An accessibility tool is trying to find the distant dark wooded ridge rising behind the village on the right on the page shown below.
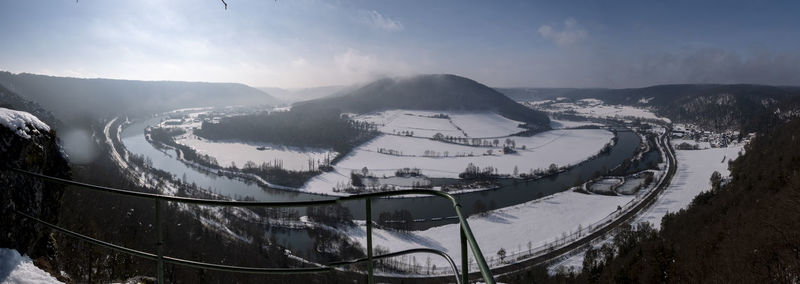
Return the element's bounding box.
[498,84,800,132]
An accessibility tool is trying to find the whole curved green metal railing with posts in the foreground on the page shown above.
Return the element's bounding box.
[10,169,495,283]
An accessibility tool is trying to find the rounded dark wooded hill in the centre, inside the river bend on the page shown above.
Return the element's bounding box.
[294,74,550,129]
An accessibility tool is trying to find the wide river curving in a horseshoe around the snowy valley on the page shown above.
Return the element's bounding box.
[121,118,658,228]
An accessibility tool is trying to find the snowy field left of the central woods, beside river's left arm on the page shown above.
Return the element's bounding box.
[175,135,337,171]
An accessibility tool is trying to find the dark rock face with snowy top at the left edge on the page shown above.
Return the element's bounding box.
[0,108,70,264]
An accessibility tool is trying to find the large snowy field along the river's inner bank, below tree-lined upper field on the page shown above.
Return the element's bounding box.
[303,129,613,194]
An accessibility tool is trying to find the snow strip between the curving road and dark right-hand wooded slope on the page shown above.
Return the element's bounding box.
[637,144,743,228]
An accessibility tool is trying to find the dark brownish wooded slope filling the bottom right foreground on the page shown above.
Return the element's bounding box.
[520,119,800,283]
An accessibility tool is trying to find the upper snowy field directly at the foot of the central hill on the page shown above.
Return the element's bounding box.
[353,110,525,138]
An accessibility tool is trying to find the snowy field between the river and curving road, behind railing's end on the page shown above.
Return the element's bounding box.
[348,191,634,267]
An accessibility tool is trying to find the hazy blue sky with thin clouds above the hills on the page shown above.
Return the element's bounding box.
[0,0,800,88]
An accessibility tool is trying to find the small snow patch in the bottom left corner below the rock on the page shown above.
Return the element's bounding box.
[0,248,63,284]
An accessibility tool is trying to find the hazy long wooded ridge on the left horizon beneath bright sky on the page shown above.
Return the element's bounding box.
[0,72,277,122]
